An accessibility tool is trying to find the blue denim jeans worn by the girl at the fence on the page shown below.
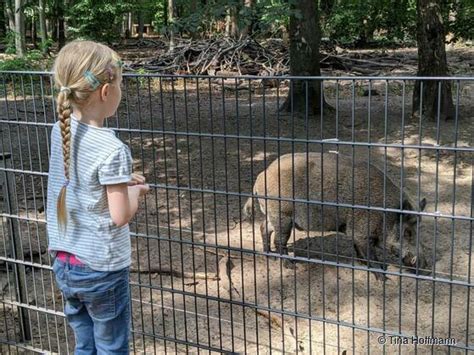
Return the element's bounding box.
[53,259,130,355]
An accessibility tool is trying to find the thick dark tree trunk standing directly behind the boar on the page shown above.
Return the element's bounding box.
[281,0,326,114]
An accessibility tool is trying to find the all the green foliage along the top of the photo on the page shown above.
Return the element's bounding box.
[0,0,468,51]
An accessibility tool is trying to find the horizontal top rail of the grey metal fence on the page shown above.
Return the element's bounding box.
[0,70,474,81]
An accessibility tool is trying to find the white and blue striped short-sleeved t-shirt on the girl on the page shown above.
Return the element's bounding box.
[46,115,132,271]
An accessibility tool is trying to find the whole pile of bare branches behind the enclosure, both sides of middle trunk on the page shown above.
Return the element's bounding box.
[124,37,417,76]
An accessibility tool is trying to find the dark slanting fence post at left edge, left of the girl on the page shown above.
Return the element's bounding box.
[0,153,31,341]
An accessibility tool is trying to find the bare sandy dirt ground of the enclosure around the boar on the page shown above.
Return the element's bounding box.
[0,48,474,354]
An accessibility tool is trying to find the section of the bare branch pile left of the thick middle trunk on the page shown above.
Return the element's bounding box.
[127,37,289,76]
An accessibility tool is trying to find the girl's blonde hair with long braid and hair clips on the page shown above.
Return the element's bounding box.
[53,41,122,231]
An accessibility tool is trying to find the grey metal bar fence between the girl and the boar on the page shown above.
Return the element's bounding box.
[0,72,474,354]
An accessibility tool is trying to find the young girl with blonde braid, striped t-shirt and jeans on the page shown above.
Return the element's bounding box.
[47,41,149,354]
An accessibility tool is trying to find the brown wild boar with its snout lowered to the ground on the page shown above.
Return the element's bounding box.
[244,153,427,279]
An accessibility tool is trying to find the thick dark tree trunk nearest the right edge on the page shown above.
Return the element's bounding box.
[413,0,454,120]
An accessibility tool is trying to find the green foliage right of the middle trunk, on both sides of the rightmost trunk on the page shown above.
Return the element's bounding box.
[321,0,474,45]
